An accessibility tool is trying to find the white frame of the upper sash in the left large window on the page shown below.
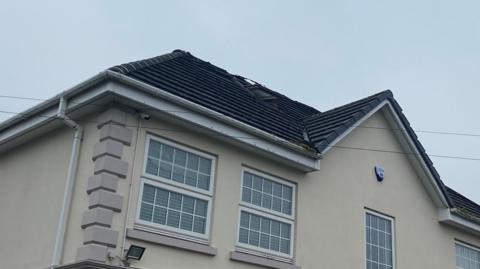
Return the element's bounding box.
[142,134,216,196]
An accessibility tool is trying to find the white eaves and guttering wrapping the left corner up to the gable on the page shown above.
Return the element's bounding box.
[0,71,320,172]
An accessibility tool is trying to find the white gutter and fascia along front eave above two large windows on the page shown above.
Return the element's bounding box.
[106,79,320,172]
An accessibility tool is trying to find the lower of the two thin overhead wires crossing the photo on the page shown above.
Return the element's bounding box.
[0,110,480,161]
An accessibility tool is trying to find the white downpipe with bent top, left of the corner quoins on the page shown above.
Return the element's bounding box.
[50,97,83,268]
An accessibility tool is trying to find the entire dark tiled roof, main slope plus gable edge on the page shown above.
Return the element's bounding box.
[109,50,480,218]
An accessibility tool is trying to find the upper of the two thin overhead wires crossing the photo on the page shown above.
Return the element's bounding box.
[0,95,480,137]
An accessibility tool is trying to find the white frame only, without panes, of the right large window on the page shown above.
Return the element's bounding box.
[235,167,297,261]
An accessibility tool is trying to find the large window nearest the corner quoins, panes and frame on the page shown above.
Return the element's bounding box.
[137,135,215,239]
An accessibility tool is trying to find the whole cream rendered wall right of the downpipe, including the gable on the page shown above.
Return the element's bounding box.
[57,107,480,268]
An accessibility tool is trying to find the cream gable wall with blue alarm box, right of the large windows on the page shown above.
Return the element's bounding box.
[297,112,480,269]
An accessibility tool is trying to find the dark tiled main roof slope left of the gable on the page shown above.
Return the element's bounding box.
[110,50,319,143]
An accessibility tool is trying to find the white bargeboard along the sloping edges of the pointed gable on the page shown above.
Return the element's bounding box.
[321,100,449,208]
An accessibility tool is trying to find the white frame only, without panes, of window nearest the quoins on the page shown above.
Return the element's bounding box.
[135,134,216,243]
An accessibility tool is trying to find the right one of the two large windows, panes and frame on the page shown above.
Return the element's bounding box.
[237,169,295,258]
